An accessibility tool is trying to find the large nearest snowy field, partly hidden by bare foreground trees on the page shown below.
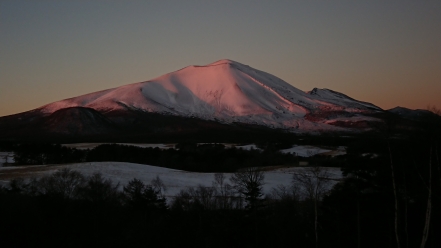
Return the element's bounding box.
[0,162,342,197]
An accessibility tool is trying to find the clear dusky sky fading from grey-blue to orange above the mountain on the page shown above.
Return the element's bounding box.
[0,0,441,116]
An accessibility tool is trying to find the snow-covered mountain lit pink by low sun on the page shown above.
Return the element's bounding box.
[31,60,382,132]
